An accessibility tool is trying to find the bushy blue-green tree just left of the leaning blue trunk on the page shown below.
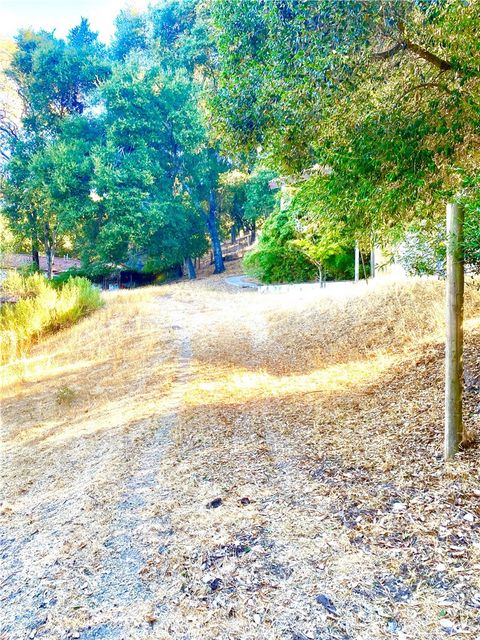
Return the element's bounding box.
[74,58,206,270]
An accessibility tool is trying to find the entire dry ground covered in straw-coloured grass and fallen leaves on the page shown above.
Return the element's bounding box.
[0,266,480,640]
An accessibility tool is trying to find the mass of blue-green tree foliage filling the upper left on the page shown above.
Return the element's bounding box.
[2,0,263,274]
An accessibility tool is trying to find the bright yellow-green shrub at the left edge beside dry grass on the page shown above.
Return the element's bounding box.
[0,272,102,362]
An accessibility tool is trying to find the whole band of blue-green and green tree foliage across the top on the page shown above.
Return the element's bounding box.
[6,0,480,279]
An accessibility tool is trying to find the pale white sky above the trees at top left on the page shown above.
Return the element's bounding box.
[0,0,151,42]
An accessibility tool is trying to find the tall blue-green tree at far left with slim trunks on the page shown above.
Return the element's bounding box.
[3,19,109,276]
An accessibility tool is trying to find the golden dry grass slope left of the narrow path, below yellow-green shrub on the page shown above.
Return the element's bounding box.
[1,289,182,500]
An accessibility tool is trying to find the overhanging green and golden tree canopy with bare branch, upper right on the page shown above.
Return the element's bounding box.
[210,0,480,255]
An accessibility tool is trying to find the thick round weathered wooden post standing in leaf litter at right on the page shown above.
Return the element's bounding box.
[444,204,464,460]
